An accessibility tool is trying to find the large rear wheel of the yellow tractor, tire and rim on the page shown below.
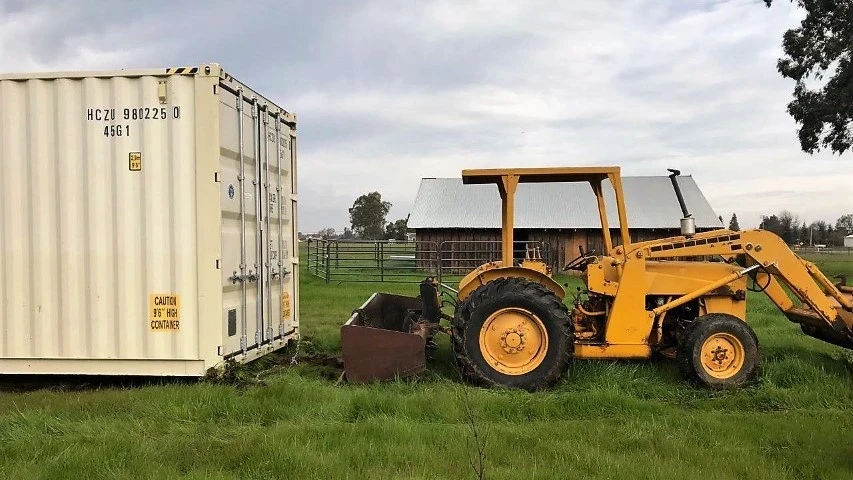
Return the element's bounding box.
[452,278,574,391]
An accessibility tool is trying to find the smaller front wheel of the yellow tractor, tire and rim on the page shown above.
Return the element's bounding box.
[676,313,761,390]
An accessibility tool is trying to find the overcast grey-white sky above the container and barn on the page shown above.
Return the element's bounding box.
[0,0,853,232]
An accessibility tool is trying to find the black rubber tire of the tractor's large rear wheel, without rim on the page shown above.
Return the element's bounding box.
[452,278,574,391]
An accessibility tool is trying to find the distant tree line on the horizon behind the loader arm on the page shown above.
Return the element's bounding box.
[729,210,853,247]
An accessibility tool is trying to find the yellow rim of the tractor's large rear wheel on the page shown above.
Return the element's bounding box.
[480,307,548,375]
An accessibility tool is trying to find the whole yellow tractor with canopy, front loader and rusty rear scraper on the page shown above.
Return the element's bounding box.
[341,167,853,390]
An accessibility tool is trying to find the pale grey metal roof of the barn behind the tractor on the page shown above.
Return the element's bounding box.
[408,176,722,229]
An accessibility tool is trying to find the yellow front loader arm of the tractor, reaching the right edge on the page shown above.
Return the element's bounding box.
[617,230,853,349]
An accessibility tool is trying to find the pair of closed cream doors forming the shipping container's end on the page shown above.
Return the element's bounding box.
[220,88,298,358]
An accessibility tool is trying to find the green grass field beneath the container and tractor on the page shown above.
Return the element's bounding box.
[0,256,853,480]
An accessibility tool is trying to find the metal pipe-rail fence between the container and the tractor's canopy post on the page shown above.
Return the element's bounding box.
[306,239,551,283]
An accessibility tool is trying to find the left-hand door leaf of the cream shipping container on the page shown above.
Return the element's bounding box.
[220,86,263,358]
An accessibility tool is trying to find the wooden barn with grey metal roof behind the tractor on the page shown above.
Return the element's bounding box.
[408,176,723,271]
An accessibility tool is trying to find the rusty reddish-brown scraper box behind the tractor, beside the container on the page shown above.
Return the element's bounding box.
[341,293,427,383]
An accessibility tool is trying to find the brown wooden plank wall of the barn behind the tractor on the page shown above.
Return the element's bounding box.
[415,228,712,273]
